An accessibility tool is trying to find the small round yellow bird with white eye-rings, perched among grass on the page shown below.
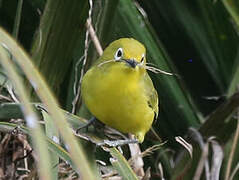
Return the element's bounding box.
[82,38,158,143]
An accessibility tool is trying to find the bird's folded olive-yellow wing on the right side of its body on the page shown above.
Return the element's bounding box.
[144,73,159,119]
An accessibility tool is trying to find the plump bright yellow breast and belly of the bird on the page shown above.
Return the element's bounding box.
[82,63,154,142]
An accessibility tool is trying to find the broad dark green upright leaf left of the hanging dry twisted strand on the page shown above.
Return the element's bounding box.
[31,0,88,97]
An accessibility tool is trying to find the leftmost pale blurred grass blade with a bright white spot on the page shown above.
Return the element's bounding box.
[0,46,52,180]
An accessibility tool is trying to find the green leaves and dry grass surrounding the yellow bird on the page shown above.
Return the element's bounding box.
[0,0,239,180]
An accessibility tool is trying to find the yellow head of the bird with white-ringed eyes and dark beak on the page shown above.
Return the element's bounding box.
[98,38,146,69]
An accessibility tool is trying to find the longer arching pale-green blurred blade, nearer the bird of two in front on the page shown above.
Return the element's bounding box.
[0,29,94,179]
